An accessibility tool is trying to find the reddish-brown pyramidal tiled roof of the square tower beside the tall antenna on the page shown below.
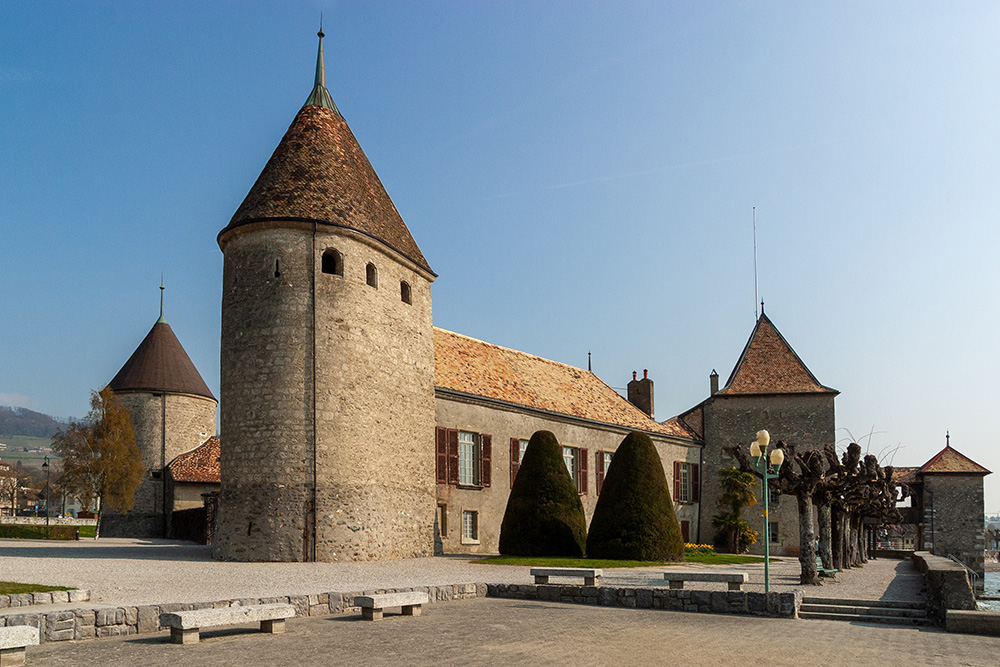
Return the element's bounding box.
[718,312,839,395]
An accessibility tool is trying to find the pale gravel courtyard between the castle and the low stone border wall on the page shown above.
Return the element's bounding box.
[0,538,923,606]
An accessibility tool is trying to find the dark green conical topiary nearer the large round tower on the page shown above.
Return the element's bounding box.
[500,431,587,558]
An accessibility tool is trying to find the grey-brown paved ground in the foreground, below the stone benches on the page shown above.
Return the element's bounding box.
[28,598,997,667]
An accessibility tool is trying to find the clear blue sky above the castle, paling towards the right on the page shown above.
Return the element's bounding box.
[0,0,1000,511]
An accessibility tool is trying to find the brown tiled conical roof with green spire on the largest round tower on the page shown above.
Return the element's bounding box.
[219,33,433,274]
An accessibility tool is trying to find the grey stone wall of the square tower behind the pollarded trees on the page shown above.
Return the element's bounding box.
[701,394,836,555]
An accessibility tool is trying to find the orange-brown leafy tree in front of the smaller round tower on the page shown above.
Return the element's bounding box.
[52,387,145,535]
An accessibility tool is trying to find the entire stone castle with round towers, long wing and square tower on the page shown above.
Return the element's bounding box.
[99,33,982,576]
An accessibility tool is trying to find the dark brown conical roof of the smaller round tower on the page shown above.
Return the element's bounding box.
[108,317,215,401]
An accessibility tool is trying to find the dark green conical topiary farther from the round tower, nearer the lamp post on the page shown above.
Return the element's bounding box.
[587,431,684,560]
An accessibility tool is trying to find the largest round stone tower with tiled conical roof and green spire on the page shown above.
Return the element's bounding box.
[214,32,435,561]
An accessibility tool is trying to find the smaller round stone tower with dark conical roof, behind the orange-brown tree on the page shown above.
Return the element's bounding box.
[101,286,218,537]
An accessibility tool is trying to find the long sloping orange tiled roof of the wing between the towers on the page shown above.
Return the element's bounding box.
[434,327,692,440]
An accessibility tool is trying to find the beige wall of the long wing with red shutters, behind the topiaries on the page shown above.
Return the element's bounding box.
[427,393,701,553]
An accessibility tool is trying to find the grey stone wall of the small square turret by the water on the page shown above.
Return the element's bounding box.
[920,473,986,593]
